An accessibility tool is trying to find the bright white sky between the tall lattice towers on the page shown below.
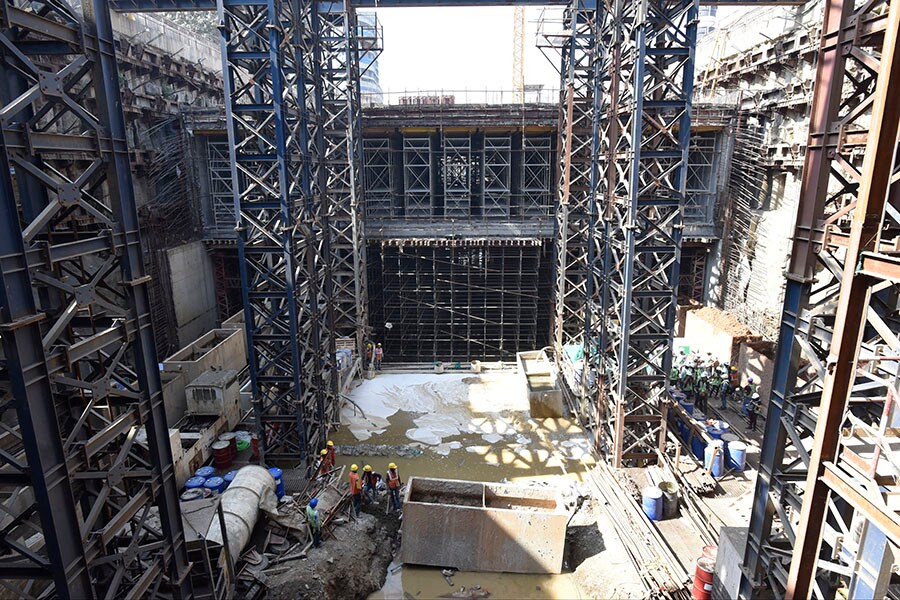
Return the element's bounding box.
[366,6,562,101]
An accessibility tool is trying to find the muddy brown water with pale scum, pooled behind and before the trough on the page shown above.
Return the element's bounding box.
[332,373,594,599]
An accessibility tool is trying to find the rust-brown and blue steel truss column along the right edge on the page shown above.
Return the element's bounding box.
[741,0,900,598]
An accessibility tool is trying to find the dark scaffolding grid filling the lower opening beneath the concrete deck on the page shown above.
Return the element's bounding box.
[369,239,551,364]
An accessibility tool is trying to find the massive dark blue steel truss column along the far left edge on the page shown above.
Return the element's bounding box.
[0,0,190,598]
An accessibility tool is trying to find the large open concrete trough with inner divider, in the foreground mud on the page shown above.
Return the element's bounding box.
[400,477,569,573]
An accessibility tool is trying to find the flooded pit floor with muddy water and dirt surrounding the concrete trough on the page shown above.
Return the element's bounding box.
[269,372,641,600]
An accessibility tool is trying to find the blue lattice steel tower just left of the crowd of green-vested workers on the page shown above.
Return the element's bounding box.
[606,0,697,466]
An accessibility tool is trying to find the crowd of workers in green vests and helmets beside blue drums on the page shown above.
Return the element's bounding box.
[669,350,760,431]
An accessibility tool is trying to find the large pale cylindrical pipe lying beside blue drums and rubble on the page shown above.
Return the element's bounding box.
[206,465,275,562]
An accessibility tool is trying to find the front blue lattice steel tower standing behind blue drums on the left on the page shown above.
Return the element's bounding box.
[218,0,318,462]
